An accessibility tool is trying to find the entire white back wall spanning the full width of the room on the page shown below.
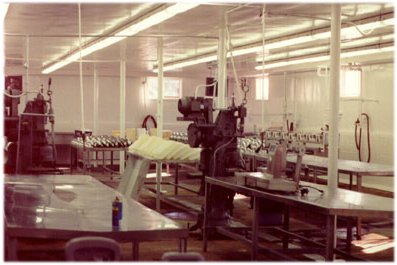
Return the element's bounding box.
[20,63,394,190]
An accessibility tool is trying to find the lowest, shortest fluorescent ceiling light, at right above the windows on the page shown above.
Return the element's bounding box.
[255,46,394,70]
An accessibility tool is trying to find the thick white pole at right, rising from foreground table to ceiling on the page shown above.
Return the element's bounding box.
[327,4,341,192]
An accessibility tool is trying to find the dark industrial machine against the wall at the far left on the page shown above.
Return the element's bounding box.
[4,78,56,174]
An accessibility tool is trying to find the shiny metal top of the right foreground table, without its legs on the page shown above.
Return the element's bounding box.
[205,177,394,218]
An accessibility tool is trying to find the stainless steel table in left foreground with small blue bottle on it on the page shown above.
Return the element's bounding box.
[4,175,188,260]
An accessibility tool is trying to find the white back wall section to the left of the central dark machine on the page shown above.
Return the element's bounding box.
[25,76,205,134]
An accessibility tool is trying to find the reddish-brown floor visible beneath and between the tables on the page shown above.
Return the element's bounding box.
[9,166,394,262]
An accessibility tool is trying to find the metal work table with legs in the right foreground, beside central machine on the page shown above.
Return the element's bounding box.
[203,177,394,260]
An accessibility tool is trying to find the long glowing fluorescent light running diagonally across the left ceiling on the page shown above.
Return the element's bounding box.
[42,3,199,74]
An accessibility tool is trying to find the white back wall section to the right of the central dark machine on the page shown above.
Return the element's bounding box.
[246,63,394,190]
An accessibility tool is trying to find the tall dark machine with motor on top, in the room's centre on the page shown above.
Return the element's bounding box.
[178,81,248,230]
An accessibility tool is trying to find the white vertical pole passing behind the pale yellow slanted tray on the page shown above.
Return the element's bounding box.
[156,37,164,211]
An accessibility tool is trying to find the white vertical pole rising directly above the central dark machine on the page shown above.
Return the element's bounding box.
[217,15,227,109]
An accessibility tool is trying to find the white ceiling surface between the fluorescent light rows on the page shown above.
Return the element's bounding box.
[4,3,394,75]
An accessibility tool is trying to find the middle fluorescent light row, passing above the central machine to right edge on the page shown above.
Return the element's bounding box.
[153,18,394,72]
